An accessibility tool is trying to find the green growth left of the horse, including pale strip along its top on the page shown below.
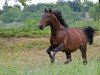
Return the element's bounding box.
[0,23,50,37]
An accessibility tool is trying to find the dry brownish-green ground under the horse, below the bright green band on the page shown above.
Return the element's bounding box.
[0,35,100,75]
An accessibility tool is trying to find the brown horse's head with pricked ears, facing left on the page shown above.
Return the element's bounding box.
[39,8,52,30]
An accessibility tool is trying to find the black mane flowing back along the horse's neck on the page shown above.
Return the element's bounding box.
[52,10,68,27]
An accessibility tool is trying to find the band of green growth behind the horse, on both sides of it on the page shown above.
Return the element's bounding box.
[0,21,100,37]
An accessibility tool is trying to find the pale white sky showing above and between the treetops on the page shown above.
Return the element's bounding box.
[0,0,98,10]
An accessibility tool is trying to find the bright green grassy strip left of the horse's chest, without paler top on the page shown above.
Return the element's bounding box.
[0,26,50,37]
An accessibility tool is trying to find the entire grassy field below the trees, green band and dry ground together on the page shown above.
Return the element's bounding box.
[0,20,100,75]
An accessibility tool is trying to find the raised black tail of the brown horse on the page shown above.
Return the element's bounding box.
[84,27,95,45]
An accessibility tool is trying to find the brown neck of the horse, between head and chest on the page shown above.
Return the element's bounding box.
[50,17,65,35]
